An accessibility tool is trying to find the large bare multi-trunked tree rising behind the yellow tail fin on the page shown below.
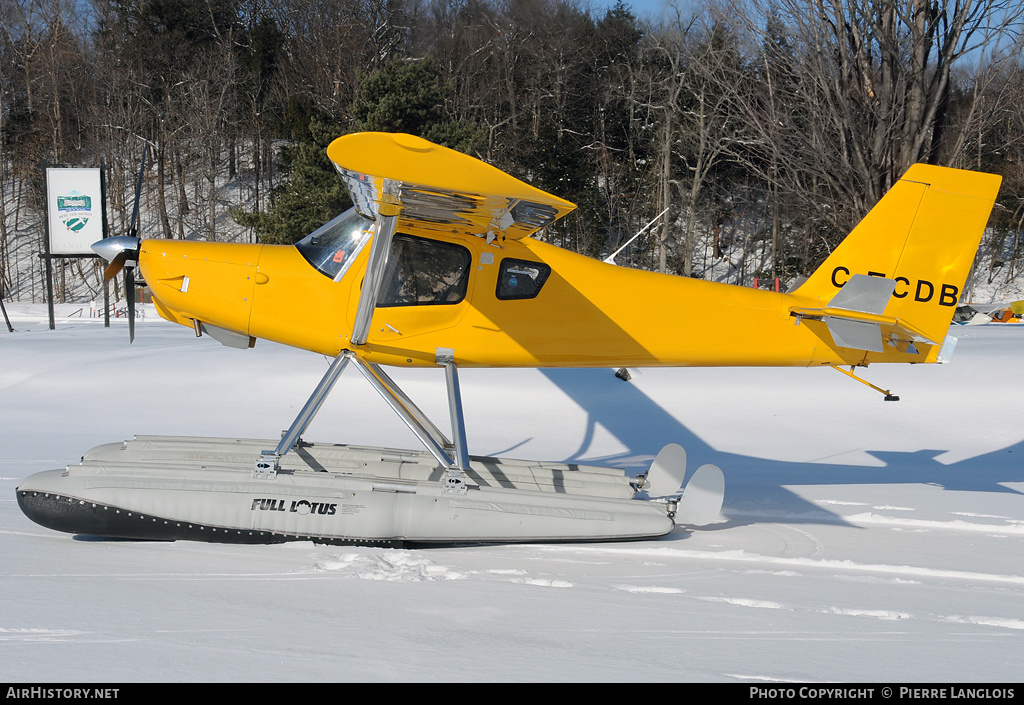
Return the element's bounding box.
[720,0,1024,233]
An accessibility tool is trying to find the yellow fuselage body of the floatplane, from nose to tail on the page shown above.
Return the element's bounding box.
[139,227,913,367]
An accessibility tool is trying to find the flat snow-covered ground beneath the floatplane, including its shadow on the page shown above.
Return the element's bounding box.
[0,303,1024,685]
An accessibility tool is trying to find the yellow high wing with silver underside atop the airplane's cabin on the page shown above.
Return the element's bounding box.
[327,132,575,240]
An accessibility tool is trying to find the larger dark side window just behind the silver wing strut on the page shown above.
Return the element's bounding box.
[377,234,472,306]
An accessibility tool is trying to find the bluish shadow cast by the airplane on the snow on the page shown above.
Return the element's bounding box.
[541,369,1024,531]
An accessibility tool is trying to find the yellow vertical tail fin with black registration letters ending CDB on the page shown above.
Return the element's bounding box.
[794,164,1001,342]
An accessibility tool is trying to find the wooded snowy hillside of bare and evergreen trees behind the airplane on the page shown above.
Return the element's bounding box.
[0,0,1024,301]
